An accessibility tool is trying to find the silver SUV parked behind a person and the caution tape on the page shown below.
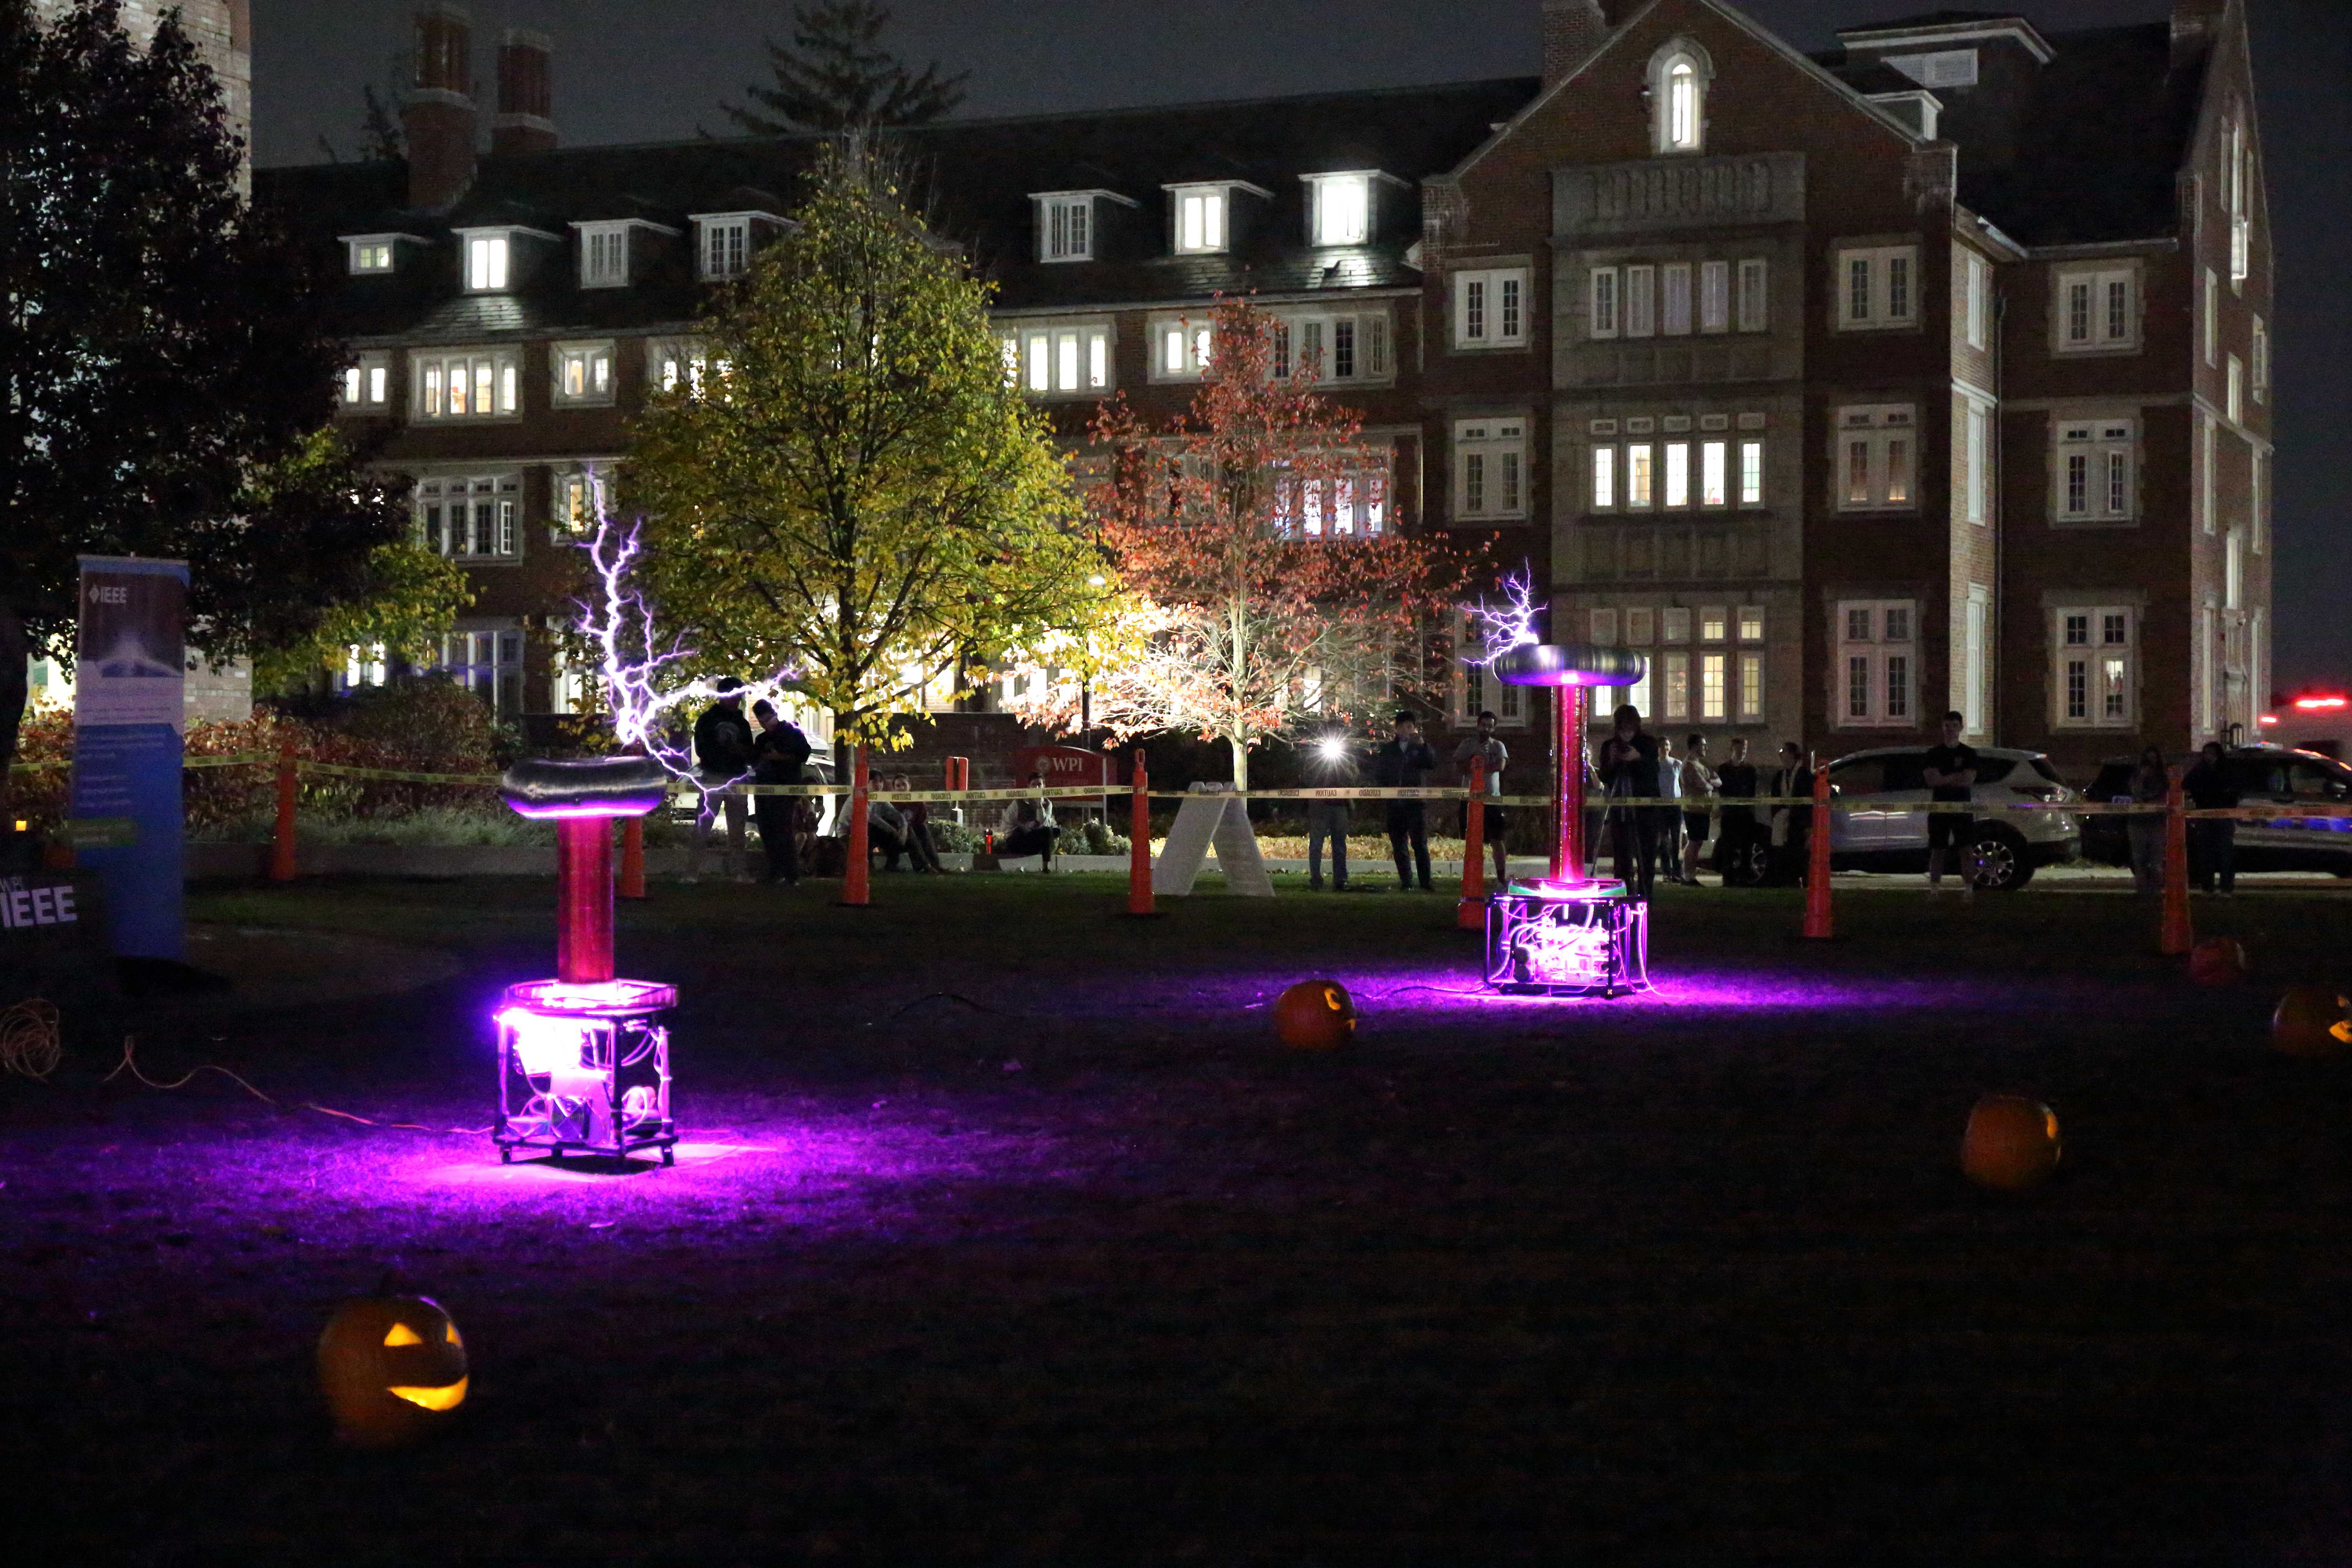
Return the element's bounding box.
[1778,745,2082,893]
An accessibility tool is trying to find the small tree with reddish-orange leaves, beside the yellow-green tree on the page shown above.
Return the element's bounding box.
[1011,301,1463,790]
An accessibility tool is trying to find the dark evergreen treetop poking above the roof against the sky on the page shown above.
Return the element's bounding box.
[720,0,971,136]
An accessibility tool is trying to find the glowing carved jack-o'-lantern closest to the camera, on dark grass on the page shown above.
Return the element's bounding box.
[318,1295,466,1448]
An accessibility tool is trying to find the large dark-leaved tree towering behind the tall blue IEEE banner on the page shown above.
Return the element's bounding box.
[0,0,405,790]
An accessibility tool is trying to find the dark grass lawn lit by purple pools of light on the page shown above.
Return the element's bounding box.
[0,877,2352,1566]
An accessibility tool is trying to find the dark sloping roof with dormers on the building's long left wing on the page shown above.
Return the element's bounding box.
[254,78,1538,336]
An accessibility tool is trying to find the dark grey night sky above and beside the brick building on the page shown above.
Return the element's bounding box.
[254,0,2352,691]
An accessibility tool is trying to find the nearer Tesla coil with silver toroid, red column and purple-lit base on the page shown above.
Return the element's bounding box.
[492,757,677,1166]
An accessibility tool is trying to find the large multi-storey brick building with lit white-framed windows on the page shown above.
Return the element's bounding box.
[261,0,2270,776]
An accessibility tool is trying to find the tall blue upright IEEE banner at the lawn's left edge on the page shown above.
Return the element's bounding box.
[68,555,188,959]
